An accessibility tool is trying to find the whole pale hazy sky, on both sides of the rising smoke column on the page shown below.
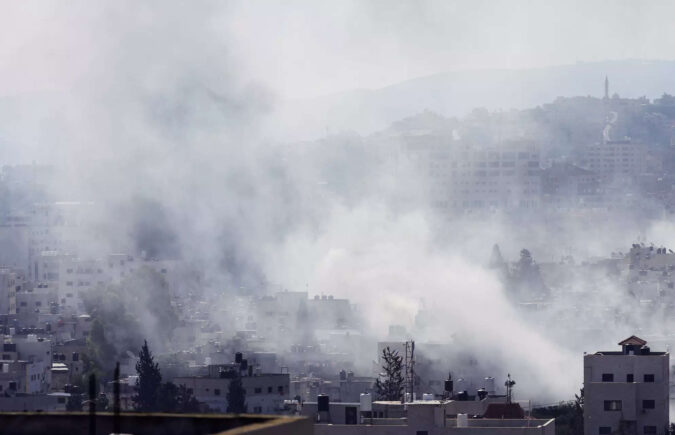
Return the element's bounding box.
[0,0,675,97]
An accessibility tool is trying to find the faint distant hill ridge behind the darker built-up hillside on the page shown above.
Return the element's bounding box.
[274,60,675,139]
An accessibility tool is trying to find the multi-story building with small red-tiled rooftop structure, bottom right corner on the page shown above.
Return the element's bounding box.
[584,336,670,435]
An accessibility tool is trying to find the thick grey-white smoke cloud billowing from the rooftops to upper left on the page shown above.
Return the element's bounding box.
[0,2,675,406]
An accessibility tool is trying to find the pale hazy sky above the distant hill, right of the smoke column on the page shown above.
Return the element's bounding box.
[234,0,675,96]
